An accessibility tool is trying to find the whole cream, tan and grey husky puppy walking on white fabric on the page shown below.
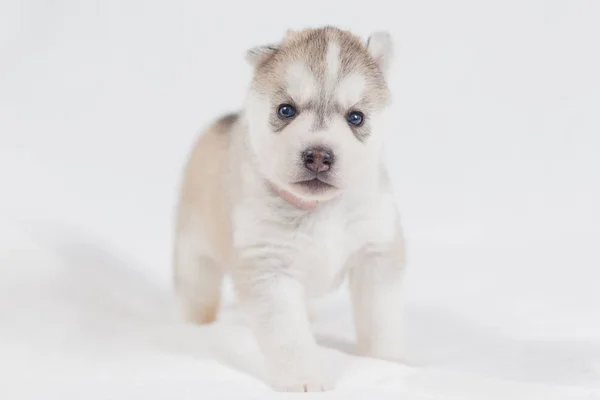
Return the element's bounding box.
[174,26,404,392]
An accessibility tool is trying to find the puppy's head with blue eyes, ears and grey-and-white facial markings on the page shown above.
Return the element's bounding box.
[246,28,392,200]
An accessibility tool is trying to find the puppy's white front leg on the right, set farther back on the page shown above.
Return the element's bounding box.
[349,244,405,361]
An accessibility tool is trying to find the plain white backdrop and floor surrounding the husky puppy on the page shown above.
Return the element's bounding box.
[0,0,600,399]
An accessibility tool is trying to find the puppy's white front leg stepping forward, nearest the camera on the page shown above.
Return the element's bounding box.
[234,260,330,392]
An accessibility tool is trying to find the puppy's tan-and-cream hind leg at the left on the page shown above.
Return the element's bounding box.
[174,228,223,324]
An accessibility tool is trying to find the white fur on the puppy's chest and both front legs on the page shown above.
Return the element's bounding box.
[232,159,403,391]
